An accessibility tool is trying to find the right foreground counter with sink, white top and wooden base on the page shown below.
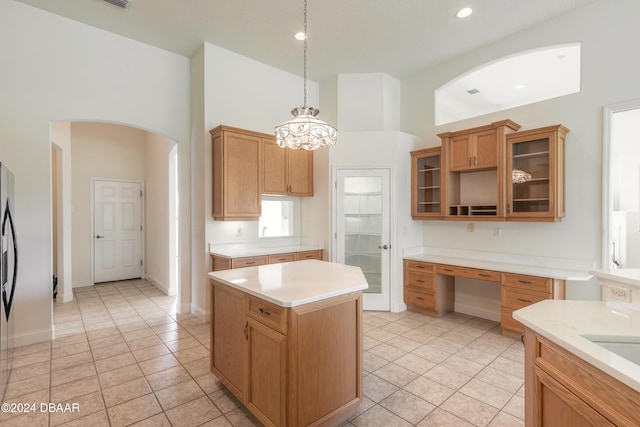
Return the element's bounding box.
[513,300,640,427]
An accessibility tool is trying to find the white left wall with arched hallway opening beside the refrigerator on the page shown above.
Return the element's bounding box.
[0,0,190,345]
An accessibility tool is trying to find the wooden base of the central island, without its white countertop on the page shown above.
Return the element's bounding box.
[211,280,362,427]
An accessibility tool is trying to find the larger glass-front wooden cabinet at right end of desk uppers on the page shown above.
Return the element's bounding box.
[506,125,569,221]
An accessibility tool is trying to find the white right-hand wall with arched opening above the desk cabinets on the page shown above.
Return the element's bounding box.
[402,0,640,299]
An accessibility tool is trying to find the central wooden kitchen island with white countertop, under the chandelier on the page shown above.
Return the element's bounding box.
[209,260,368,427]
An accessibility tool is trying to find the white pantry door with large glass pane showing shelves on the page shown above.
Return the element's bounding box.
[334,169,391,311]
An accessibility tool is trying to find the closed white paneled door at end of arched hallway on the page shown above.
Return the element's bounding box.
[93,180,142,283]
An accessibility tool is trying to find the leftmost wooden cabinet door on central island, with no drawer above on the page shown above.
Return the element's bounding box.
[211,285,247,399]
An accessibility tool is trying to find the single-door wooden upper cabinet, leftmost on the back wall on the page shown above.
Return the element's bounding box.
[210,126,267,221]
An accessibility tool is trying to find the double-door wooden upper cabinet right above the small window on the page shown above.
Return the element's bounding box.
[262,137,313,197]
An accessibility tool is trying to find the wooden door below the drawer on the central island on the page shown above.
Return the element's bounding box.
[246,317,287,426]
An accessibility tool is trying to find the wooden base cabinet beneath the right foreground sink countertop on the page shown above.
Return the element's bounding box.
[525,328,640,427]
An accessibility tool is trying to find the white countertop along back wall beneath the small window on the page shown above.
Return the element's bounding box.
[209,239,324,258]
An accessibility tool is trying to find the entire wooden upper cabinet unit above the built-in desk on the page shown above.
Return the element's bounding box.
[411,120,568,221]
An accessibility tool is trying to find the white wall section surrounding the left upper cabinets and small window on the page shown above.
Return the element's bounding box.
[192,43,328,317]
